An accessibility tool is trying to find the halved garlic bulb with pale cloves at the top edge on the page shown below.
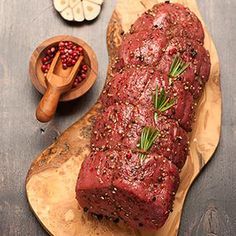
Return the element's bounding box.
[53,0,103,22]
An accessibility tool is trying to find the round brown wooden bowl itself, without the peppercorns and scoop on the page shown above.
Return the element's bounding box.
[29,35,98,102]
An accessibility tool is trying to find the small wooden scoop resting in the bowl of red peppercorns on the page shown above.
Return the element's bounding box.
[36,52,83,122]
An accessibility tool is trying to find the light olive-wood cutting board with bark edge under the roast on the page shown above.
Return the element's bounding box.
[26,0,221,236]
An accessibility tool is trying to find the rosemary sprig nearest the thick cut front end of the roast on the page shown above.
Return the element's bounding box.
[139,127,160,160]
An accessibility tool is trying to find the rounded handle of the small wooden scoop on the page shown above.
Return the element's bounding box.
[36,84,61,123]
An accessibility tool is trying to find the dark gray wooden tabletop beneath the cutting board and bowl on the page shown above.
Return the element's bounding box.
[0,0,236,236]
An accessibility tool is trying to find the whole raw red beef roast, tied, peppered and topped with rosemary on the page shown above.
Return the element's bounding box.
[76,3,211,230]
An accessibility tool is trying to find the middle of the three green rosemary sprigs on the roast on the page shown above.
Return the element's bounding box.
[153,86,176,121]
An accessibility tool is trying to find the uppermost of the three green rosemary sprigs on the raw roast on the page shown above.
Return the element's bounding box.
[169,55,190,78]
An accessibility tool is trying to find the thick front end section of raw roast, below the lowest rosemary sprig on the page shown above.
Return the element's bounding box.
[76,151,179,229]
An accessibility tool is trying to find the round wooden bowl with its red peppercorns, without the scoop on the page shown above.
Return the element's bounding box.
[29,35,98,101]
